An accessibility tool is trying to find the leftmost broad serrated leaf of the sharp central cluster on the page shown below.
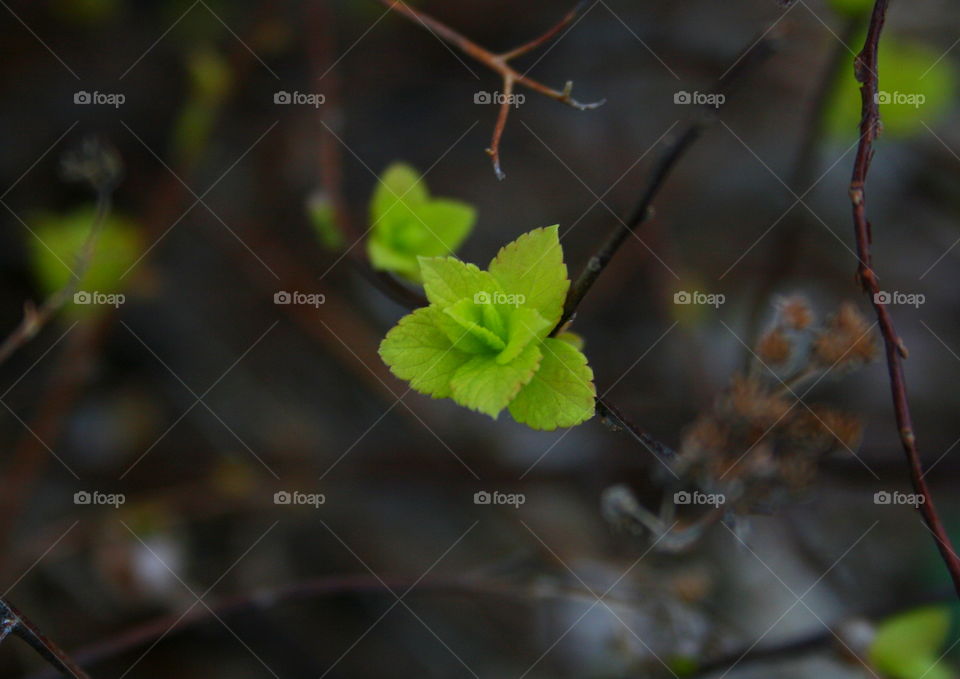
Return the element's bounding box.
[380,307,470,398]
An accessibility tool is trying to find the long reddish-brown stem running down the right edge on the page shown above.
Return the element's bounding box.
[850,0,960,595]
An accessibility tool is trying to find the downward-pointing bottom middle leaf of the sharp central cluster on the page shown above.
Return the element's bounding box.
[450,344,542,419]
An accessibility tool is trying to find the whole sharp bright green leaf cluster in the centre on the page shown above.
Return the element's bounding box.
[380,226,596,430]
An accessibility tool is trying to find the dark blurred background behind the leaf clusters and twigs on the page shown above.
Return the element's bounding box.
[0,0,960,679]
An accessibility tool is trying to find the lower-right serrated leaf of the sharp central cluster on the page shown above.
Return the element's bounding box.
[510,337,597,431]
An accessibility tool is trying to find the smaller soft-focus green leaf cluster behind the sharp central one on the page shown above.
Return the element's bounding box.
[367,163,477,282]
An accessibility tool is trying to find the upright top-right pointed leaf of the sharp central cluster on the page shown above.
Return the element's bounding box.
[490,226,570,327]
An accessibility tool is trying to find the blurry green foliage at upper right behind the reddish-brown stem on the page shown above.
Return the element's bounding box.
[826,36,957,138]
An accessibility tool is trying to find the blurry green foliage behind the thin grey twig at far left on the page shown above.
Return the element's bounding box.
[28,206,142,306]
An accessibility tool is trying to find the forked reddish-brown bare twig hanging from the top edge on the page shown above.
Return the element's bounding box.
[379,0,606,179]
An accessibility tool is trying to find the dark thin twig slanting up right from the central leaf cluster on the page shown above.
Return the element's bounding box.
[553,34,776,334]
